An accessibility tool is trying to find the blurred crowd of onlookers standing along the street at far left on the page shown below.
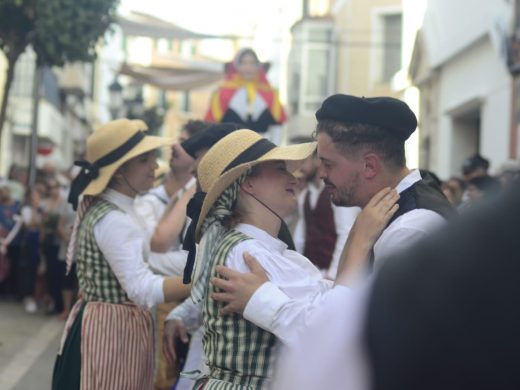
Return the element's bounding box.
[0,164,77,319]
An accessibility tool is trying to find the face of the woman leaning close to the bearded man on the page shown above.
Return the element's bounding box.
[242,161,297,217]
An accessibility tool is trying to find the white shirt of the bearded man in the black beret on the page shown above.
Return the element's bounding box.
[244,171,445,390]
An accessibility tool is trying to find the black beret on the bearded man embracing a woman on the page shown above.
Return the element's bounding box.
[316,94,417,140]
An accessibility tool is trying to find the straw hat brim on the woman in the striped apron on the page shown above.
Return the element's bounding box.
[83,135,175,195]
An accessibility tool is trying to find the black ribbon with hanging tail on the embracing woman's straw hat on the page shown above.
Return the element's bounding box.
[182,138,276,284]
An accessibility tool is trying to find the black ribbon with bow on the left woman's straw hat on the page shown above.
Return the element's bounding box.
[68,131,146,210]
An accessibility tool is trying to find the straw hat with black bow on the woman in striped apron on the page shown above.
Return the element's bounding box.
[69,119,174,209]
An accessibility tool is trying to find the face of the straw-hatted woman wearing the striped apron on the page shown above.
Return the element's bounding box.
[117,150,159,192]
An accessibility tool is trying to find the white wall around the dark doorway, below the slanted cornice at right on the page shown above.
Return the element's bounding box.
[432,35,511,178]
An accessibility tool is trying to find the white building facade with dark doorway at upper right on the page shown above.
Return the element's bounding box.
[410,0,512,179]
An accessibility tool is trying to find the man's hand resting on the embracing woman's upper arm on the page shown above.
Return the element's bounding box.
[211,252,269,315]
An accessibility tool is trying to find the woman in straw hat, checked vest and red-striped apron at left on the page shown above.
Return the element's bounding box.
[53,119,189,390]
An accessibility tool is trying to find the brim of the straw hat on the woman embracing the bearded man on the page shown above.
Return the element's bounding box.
[195,142,316,242]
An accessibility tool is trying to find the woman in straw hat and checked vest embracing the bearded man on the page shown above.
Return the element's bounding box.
[185,130,397,390]
